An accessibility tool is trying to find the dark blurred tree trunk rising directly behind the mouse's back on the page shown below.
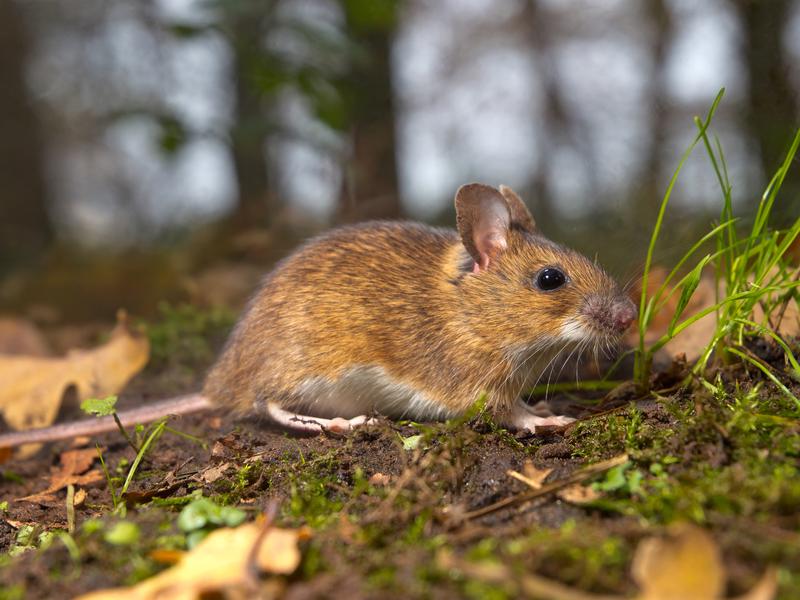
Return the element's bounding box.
[339,0,401,221]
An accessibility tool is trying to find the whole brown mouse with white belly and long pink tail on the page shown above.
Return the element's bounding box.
[0,183,637,446]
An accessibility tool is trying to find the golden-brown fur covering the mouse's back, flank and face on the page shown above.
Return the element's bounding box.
[204,192,621,418]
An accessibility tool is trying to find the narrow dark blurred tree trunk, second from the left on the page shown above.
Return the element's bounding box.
[228,3,279,227]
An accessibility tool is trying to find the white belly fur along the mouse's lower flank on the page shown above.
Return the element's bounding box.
[292,365,455,421]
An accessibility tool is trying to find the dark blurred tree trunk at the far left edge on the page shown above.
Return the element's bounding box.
[0,0,53,271]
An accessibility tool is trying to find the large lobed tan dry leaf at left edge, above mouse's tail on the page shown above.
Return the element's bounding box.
[0,314,150,430]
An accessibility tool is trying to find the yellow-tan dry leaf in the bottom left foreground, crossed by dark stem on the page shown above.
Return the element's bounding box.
[78,523,302,600]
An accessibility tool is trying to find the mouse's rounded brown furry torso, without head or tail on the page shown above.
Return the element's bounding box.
[205,222,510,420]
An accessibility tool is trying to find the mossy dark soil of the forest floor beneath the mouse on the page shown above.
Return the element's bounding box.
[0,308,800,600]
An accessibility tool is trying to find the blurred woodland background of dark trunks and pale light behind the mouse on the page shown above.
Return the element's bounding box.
[0,0,800,323]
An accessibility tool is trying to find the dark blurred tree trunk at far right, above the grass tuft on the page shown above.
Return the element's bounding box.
[732,0,800,209]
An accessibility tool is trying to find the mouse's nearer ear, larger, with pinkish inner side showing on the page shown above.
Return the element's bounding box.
[456,183,511,273]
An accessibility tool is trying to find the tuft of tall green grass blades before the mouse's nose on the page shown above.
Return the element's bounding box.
[635,90,800,398]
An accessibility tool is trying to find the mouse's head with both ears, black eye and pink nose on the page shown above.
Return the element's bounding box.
[456,183,636,352]
